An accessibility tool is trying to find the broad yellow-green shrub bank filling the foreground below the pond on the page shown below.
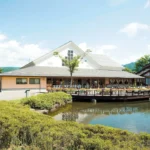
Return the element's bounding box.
[0,101,150,150]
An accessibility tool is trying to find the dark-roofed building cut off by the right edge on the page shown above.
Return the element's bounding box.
[137,64,150,85]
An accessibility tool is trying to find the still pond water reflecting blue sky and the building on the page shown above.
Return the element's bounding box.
[54,101,150,133]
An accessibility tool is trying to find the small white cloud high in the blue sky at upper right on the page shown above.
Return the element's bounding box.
[120,22,150,37]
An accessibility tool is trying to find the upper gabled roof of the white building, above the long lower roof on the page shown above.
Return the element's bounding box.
[22,41,123,70]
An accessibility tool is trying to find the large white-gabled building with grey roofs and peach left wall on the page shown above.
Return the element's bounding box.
[0,42,142,95]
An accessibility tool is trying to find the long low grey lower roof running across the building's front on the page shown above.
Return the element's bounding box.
[0,66,143,78]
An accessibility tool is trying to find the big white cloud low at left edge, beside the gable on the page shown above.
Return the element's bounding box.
[0,34,48,67]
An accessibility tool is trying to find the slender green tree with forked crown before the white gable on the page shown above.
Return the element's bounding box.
[53,52,81,87]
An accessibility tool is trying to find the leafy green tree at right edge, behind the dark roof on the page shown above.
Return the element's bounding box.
[135,55,150,72]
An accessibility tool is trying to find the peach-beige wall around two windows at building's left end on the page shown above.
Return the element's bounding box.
[2,77,46,90]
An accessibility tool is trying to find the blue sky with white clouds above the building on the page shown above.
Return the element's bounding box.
[0,0,150,66]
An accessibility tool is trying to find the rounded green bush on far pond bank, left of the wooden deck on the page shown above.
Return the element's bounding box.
[21,92,72,110]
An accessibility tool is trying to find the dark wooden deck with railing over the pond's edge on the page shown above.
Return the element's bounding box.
[71,90,150,102]
